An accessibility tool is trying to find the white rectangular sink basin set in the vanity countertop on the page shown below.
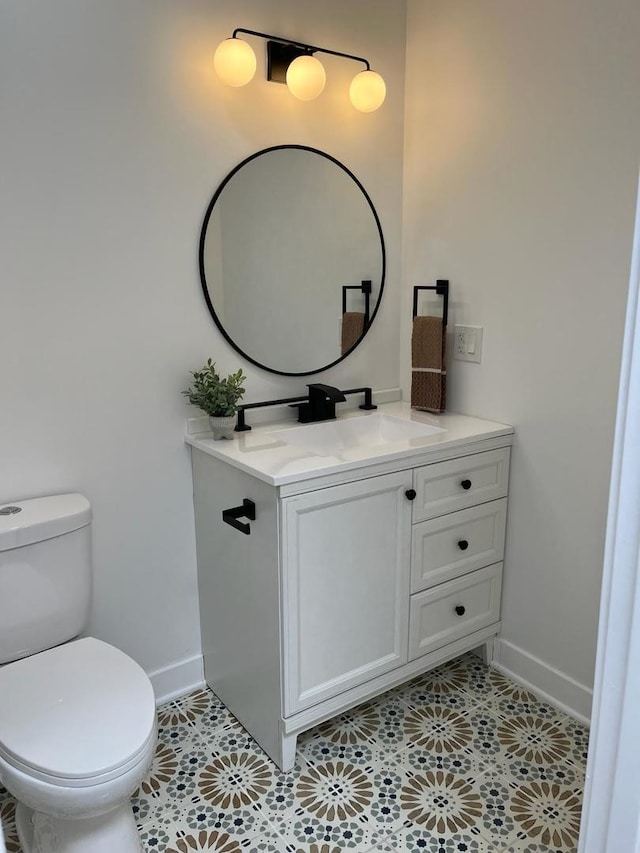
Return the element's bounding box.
[270,414,445,456]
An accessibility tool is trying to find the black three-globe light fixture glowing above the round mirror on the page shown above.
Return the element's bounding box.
[213,27,387,113]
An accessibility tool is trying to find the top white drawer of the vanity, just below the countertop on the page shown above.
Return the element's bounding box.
[413,447,509,524]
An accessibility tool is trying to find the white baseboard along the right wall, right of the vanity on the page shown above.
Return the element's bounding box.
[493,638,593,726]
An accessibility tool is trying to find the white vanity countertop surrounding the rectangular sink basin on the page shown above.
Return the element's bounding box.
[185,402,513,486]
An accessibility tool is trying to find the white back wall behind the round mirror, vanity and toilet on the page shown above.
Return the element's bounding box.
[0,0,405,692]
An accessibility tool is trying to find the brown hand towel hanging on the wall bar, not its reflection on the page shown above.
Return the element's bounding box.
[411,317,447,414]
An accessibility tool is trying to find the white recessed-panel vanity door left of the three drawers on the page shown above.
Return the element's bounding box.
[282,471,412,716]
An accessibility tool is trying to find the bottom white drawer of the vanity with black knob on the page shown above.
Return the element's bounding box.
[409,563,502,660]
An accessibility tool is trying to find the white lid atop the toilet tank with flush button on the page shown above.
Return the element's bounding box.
[0,493,91,551]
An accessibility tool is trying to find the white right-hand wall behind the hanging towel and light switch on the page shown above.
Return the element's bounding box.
[401,0,640,714]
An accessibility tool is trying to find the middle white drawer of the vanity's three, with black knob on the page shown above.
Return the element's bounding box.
[411,498,507,592]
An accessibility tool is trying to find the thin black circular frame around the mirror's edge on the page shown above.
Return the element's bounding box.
[198,145,387,376]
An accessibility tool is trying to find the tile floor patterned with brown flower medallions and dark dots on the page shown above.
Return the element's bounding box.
[0,655,588,853]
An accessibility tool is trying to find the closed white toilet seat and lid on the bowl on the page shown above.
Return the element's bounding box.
[0,637,156,787]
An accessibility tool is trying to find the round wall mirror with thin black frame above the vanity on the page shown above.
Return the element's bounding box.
[200,145,385,376]
